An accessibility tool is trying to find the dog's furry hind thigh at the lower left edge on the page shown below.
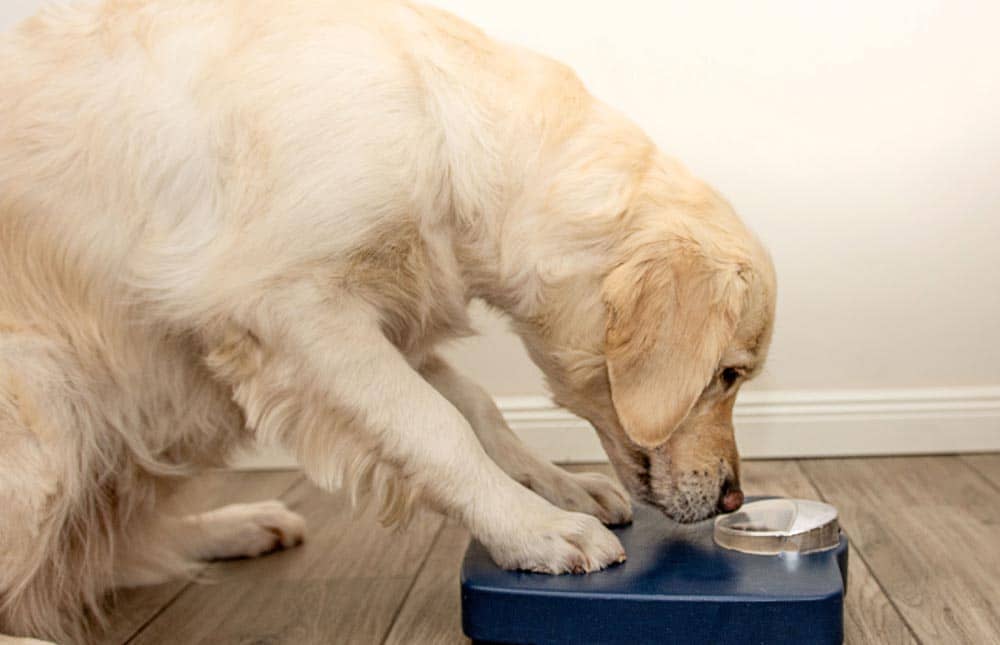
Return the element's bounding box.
[0,327,121,642]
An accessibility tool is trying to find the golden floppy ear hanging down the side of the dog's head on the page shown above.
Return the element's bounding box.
[603,244,747,448]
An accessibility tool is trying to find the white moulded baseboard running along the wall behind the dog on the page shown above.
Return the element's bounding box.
[234,386,1000,468]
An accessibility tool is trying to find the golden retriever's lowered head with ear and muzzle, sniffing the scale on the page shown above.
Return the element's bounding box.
[529,161,775,522]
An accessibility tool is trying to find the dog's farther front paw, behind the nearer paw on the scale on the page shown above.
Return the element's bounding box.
[518,466,632,525]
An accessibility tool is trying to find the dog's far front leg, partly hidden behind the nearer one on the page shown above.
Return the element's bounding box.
[420,357,632,524]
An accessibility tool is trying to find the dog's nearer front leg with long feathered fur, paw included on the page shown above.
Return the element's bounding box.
[201,290,624,571]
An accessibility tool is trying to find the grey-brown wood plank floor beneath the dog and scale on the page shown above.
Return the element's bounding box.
[105,454,1000,645]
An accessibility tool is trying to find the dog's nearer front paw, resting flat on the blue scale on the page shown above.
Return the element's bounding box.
[490,510,625,574]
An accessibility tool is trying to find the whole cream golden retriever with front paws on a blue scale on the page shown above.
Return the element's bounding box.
[0,0,775,643]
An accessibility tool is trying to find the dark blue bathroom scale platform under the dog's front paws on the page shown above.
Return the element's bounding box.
[461,498,848,645]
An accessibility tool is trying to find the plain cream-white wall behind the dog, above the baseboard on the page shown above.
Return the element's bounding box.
[0,0,1000,451]
